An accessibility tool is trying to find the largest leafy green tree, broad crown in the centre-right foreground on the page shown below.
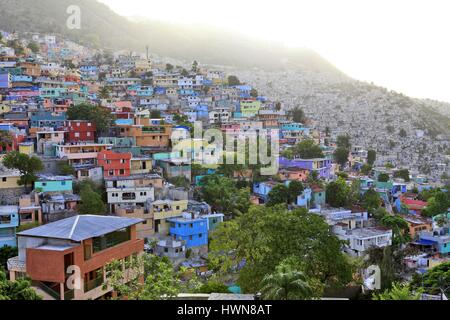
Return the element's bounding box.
[208,206,352,293]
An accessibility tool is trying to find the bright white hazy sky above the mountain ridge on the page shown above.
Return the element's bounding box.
[100,0,450,102]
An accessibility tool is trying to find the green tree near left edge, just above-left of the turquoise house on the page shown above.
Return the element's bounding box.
[3,151,44,188]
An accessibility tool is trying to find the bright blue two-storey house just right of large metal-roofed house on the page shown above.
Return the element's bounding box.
[167,213,208,249]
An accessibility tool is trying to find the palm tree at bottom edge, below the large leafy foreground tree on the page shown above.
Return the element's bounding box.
[261,263,313,300]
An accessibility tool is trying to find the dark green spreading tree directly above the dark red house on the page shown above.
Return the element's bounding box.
[67,103,114,134]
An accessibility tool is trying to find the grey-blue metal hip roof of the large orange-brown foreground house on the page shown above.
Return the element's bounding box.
[17,215,144,241]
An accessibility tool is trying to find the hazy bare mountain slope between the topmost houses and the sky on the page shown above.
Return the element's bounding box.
[0,0,340,74]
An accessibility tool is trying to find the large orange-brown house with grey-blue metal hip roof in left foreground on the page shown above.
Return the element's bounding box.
[8,215,144,300]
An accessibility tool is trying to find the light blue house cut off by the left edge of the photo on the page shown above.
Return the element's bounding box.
[0,206,19,248]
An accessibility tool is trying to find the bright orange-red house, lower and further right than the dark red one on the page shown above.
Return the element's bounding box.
[97,150,132,178]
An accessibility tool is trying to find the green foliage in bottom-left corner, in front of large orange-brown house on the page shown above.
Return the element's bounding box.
[0,269,42,301]
